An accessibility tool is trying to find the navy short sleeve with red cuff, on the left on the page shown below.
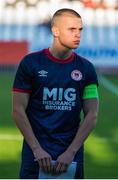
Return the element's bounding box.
[13,56,33,93]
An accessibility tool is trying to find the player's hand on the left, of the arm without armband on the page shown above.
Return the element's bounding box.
[33,148,52,172]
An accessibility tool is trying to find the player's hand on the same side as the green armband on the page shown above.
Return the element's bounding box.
[54,150,74,174]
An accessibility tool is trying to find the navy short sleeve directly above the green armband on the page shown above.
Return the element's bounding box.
[85,62,98,86]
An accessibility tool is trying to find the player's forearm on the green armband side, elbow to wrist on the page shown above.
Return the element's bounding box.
[67,112,97,154]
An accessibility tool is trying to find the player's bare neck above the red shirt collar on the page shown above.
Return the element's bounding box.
[49,46,72,59]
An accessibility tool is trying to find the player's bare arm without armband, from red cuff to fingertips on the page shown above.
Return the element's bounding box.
[12,92,51,171]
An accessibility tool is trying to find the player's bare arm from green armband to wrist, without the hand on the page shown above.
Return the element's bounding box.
[68,98,99,155]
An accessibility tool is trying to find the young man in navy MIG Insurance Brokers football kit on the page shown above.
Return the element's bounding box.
[13,9,98,179]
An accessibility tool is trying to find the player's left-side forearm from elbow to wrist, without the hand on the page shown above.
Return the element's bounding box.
[13,109,41,151]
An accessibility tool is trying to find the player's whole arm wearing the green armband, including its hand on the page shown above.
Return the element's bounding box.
[56,85,99,172]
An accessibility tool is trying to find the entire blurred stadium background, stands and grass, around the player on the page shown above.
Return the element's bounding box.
[0,0,118,179]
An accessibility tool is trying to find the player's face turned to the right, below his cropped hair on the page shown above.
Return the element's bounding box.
[52,15,82,49]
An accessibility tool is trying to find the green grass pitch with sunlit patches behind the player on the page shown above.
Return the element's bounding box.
[0,74,118,179]
